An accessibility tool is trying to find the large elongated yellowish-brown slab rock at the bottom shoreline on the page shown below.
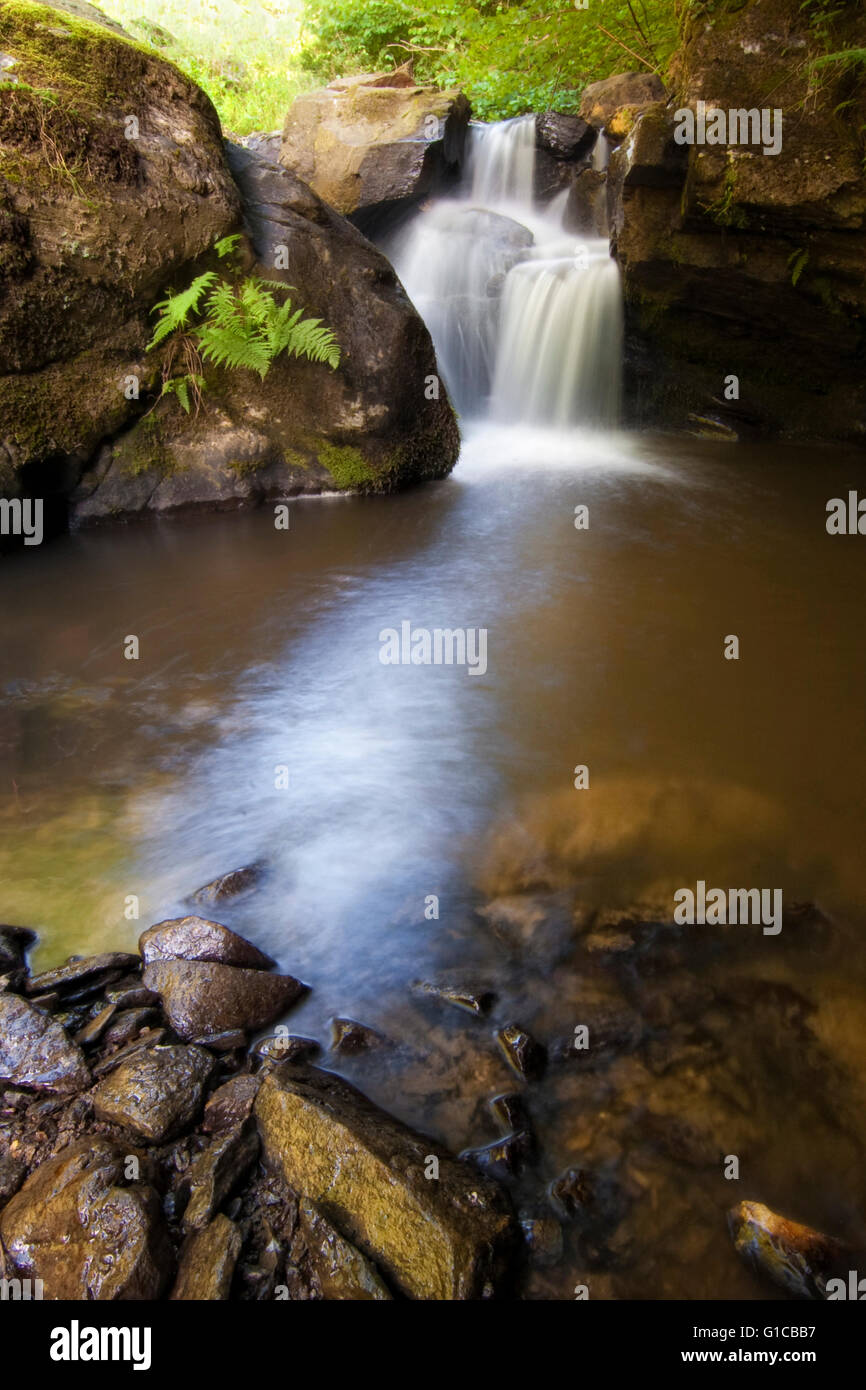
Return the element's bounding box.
[256,1063,513,1298]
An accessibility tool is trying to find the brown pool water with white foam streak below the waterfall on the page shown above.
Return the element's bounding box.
[0,430,866,1298]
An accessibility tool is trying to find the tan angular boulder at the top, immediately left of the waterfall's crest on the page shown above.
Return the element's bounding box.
[279,67,470,229]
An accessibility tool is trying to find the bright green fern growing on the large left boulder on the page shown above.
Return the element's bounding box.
[147,236,341,414]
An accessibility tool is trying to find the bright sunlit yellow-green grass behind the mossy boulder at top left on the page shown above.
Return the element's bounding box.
[101,0,316,135]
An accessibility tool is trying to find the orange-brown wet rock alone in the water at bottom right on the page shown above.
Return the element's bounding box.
[728,1202,845,1298]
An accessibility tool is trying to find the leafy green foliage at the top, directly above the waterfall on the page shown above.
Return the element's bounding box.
[302,0,677,120]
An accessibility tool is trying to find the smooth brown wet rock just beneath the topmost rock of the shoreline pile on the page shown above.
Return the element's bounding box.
[145,960,307,1038]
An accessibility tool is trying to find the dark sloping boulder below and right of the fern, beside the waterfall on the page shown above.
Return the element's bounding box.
[74,142,460,525]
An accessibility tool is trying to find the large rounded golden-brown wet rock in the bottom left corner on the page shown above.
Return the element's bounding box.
[0,1137,172,1301]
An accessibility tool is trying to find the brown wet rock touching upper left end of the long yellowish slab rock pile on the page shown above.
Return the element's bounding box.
[93,1044,214,1144]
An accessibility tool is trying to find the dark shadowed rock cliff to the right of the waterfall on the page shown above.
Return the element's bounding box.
[609,0,866,442]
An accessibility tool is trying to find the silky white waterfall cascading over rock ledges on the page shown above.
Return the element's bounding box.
[388,117,623,427]
